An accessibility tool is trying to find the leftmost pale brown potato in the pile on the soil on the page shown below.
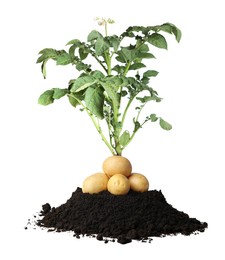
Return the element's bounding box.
[82,172,109,194]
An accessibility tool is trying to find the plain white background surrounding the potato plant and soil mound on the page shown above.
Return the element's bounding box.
[0,0,225,260]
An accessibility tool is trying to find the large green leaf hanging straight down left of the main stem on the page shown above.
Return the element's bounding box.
[84,87,105,119]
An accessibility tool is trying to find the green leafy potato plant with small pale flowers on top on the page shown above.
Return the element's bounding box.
[37,19,181,155]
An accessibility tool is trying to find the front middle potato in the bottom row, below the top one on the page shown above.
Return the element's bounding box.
[107,174,130,195]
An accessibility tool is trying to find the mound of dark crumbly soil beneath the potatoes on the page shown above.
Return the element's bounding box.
[34,188,208,244]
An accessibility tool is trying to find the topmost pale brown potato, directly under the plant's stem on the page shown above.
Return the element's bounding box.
[102,155,132,177]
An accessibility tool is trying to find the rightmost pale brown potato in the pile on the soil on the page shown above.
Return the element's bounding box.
[128,173,149,192]
